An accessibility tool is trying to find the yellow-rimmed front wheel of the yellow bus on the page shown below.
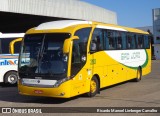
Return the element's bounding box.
[87,76,99,97]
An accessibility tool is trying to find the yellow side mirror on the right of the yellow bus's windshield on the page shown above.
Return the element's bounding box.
[63,36,79,54]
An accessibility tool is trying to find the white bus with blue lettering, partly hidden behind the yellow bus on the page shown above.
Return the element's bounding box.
[0,33,24,84]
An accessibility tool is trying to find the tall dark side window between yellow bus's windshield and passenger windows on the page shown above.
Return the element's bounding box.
[71,28,91,75]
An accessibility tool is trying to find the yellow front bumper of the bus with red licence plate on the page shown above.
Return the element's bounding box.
[18,81,71,98]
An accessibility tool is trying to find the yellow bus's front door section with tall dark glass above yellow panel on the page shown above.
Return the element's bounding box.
[71,28,91,96]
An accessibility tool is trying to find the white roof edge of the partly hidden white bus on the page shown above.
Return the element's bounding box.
[0,33,25,38]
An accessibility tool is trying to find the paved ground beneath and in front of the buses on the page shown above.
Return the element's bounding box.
[0,61,160,116]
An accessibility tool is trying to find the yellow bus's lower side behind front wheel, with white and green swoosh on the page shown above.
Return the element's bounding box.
[92,50,151,88]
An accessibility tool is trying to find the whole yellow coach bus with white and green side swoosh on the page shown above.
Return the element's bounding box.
[18,20,151,98]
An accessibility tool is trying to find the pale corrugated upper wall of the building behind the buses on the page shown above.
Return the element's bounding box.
[0,0,117,24]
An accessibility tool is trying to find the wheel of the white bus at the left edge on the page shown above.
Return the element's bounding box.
[4,71,18,85]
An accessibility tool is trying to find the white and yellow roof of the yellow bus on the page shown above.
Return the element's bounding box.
[28,20,148,34]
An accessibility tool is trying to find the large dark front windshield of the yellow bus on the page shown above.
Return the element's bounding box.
[19,33,70,80]
